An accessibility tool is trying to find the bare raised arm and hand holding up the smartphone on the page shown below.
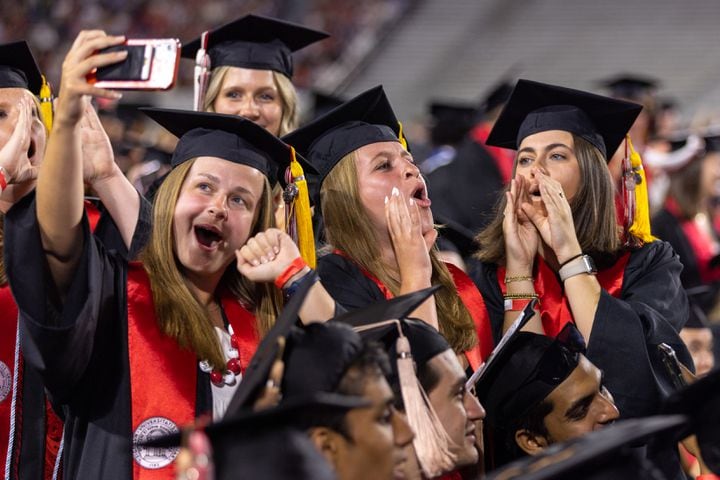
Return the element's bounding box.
[37,30,127,298]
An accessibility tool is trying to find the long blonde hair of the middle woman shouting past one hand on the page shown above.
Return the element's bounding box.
[320,151,477,352]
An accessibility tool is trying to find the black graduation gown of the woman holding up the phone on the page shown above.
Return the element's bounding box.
[5,193,212,480]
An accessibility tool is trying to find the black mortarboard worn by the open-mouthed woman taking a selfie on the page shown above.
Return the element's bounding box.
[141,108,314,184]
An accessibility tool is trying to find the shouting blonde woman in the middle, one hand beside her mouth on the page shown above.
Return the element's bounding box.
[284,87,489,368]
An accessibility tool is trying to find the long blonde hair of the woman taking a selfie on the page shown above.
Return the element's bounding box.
[140,159,281,368]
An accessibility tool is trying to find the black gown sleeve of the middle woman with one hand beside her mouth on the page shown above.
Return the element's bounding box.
[317,253,385,310]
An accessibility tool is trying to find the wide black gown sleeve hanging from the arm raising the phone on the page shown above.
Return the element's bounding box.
[5,192,121,402]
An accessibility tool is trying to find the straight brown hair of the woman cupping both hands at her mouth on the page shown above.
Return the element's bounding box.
[475,135,622,264]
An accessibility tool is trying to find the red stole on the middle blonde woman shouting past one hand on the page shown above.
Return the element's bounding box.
[333,249,492,370]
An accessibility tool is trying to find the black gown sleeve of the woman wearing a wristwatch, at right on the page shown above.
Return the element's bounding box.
[587,241,692,418]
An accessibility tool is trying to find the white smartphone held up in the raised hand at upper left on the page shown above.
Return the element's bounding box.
[88,38,180,90]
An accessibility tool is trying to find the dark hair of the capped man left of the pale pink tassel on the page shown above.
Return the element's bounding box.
[303,342,390,443]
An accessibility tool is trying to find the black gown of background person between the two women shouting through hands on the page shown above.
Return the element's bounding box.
[426,137,503,257]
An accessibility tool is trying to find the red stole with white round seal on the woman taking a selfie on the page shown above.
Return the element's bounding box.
[127,262,259,480]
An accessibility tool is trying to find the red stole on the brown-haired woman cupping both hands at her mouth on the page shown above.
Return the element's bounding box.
[497,252,630,337]
